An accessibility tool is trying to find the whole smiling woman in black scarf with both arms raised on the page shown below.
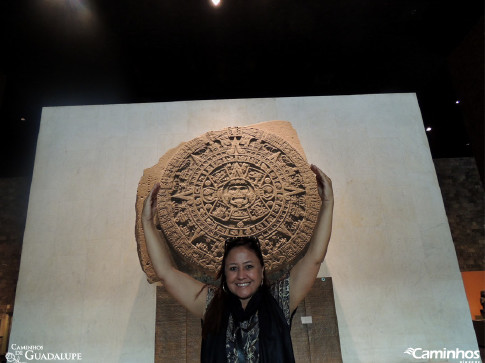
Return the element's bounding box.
[142,165,333,363]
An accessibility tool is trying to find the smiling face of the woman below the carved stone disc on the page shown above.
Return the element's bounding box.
[224,246,264,308]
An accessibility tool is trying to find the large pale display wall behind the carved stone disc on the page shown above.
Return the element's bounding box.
[10,94,478,363]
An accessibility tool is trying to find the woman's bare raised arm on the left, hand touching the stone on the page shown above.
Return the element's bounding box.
[141,183,207,319]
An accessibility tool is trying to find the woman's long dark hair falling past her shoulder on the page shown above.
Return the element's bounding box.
[202,237,269,338]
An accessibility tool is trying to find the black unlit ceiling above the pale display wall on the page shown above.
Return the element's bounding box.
[0,0,484,176]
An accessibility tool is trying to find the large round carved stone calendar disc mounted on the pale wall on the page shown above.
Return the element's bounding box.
[136,121,320,281]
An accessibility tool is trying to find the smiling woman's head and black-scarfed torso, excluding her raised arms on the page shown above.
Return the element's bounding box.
[201,237,294,362]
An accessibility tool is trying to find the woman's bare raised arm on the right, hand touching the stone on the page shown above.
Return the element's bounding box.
[290,165,333,311]
